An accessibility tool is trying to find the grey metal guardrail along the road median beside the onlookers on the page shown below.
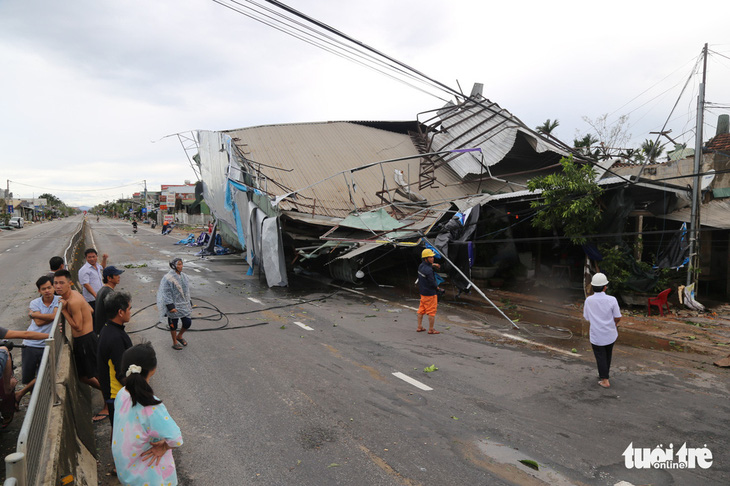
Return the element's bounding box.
[3,221,85,486]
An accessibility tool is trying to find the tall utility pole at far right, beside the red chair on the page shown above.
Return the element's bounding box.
[687,44,707,292]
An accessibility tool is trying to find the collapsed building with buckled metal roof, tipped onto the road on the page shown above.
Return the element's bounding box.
[196,86,568,286]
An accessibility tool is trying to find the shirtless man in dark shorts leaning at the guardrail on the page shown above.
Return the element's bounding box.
[53,270,101,390]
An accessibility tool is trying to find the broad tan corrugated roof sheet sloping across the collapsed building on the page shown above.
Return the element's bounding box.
[224,122,484,217]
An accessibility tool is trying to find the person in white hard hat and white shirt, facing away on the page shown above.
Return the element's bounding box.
[583,273,621,388]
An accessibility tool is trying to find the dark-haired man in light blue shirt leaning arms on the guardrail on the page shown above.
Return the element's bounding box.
[15,275,61,402]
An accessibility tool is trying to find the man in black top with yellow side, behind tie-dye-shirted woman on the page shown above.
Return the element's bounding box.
[97,290,132,430]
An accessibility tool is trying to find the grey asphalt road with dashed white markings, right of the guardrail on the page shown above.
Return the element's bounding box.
[0,218,730,485]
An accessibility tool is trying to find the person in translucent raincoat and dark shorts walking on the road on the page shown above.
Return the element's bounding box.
[157,258,193,351]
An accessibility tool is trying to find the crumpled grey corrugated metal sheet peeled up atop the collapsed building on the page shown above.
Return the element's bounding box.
[432,98,568,178]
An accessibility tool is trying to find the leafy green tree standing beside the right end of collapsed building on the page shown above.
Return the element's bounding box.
[527,156,603,245]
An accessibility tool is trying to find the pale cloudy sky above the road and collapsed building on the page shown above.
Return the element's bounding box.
[0,0,730,205]
